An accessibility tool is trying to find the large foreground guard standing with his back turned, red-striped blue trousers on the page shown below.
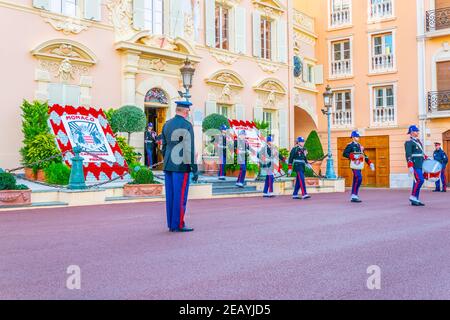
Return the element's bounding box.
[162,101,198,232]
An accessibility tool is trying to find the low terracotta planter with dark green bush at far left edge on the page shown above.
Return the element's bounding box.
[0,172,31,206]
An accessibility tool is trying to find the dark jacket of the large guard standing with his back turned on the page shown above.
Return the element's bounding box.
[162,115,197,173]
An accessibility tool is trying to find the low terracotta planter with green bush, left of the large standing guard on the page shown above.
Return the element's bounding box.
[123,164,163,197]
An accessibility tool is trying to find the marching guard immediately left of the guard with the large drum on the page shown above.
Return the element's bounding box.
[405,125,428,207]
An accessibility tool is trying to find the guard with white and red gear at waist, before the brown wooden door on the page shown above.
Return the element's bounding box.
[344,130,375,203]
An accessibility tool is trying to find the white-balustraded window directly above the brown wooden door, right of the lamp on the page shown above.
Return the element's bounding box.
[373,85,396,125]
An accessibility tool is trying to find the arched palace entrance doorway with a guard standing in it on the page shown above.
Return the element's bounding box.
[144,87,170,168]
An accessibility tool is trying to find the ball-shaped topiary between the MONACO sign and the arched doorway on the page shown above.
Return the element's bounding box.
[110,106,147,144]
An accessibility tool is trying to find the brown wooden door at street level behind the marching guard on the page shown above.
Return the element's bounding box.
[338,136,390,188]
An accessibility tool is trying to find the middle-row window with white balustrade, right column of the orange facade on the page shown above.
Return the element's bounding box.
[371,33,395,72]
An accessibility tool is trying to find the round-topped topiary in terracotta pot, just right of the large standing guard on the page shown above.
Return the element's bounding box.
[202,113,230,176]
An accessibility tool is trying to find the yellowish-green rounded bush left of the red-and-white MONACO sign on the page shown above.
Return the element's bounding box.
[25,133,62,171]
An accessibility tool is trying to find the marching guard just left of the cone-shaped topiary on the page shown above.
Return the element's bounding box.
[288,137,311,200]
